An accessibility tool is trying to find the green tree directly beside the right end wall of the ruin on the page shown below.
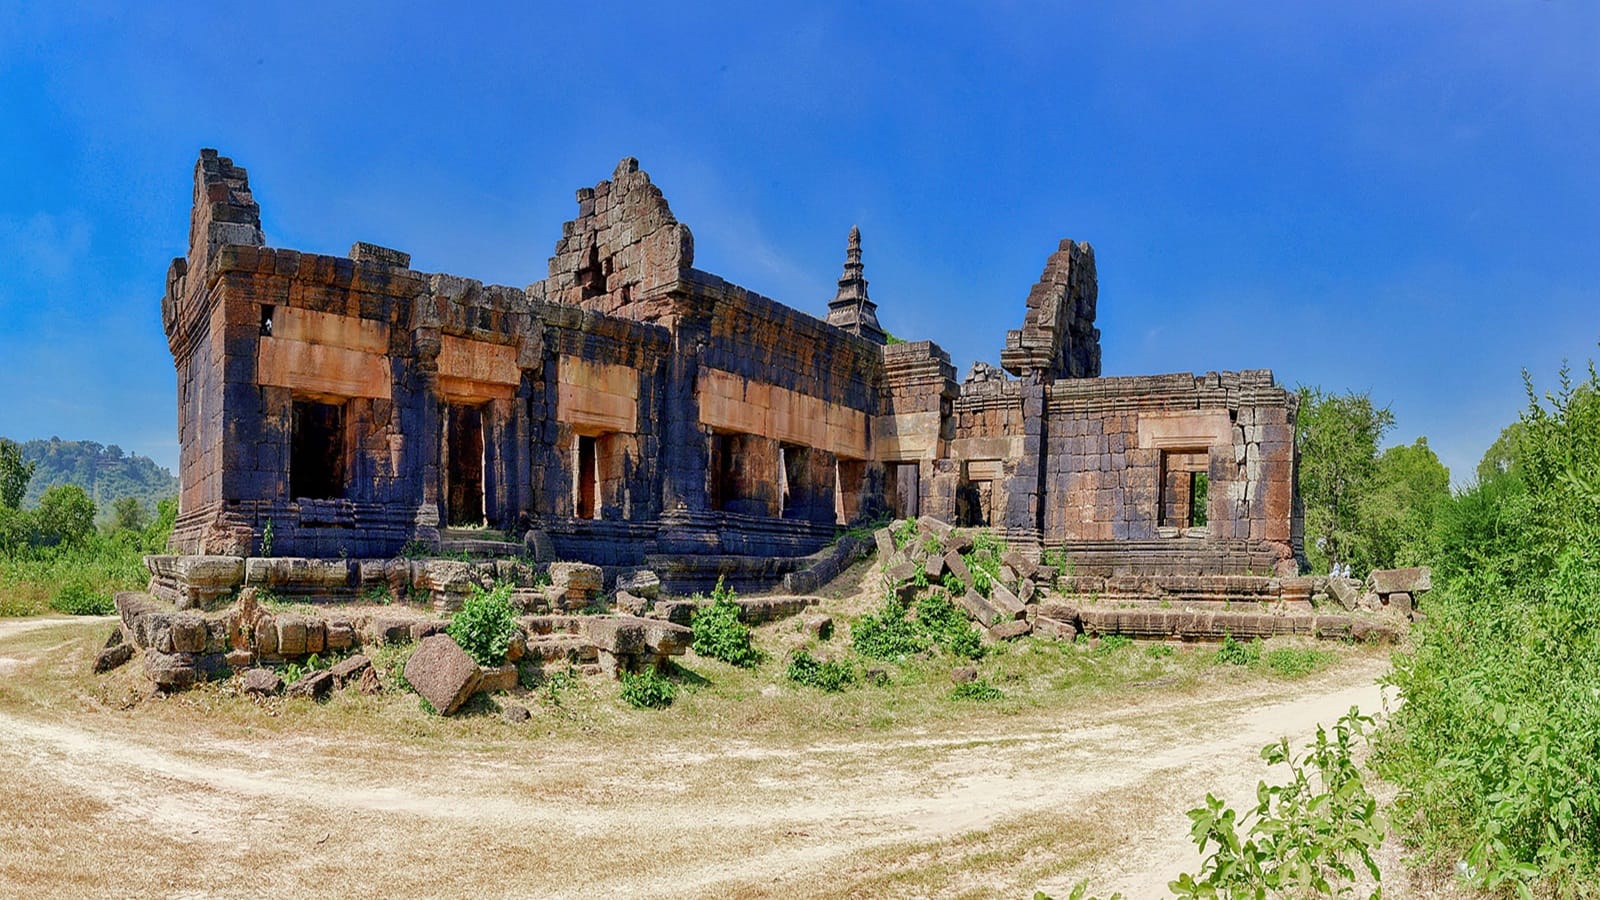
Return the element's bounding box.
[1294,386,1395,572]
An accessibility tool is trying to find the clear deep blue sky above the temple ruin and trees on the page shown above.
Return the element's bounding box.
[0,0,1600,479]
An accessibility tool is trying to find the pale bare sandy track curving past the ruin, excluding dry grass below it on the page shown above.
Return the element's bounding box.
[0,634,1384,897]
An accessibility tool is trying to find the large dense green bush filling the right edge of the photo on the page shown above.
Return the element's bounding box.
[1374,358,1600,897]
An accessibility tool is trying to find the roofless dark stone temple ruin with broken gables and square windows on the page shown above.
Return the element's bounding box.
[118,151,1388,695]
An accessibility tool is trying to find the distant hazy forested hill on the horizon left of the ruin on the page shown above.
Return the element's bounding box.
[13,437,178,516]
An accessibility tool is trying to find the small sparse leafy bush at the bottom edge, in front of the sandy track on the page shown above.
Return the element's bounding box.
[1168,708,1384,900]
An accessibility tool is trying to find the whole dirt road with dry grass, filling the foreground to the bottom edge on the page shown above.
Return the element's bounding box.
[0,614,1384,897]
